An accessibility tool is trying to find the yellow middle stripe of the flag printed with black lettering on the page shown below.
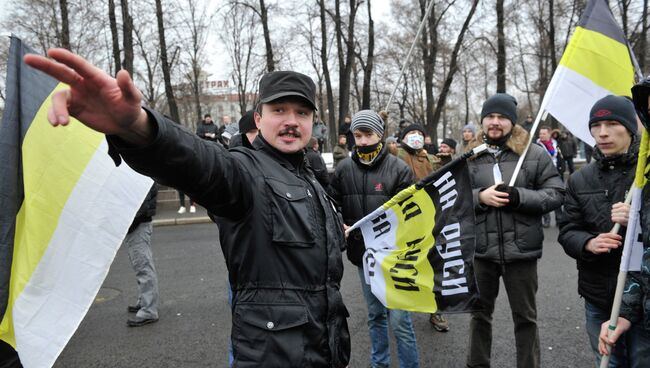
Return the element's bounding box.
[381,186,438,312]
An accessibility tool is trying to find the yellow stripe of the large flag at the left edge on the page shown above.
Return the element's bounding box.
[0,83,104,348]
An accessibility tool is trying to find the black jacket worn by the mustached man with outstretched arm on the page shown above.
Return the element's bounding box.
[109,110,350,368]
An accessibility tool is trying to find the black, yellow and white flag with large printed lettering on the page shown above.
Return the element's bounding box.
[349,158,478,313]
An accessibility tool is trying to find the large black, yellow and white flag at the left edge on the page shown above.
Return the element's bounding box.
[0,37,152,368]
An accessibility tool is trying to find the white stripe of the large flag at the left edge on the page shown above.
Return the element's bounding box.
[13,141,152,367]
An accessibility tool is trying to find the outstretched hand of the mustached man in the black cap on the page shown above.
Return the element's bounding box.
[24,49,153,145]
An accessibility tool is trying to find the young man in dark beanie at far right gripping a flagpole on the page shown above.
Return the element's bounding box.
[558,96,639,367]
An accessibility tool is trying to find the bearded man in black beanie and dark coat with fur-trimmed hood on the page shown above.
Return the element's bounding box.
[467,93,564,368]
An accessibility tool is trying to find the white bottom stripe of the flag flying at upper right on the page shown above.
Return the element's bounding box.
[545,65,612,146]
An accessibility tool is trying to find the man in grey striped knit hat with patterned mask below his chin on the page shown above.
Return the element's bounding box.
[331,110,419,368]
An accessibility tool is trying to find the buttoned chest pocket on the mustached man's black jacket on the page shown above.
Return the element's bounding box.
[266,178,315,247]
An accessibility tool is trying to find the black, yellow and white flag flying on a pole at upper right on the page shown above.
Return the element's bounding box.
[540,0,634,146]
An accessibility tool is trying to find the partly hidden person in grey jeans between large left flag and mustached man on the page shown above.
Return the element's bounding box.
[122,183,160,327]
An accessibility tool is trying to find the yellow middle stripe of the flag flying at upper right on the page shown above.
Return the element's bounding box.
[560,27,634,96]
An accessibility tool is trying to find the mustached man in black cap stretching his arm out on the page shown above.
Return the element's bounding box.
[25,49,350,368]
